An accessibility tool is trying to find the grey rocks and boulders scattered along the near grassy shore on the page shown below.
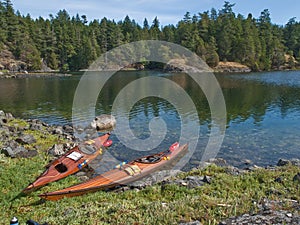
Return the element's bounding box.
[0,110,300,225]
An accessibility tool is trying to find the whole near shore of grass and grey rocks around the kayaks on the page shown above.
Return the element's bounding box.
[0,111,300,225]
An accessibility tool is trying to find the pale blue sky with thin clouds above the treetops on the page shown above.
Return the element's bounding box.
[12,0,300,25]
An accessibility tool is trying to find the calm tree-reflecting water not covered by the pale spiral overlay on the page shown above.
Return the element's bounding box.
[0,71,300,169]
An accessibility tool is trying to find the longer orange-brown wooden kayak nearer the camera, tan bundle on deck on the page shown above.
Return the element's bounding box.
[39,143,188,200]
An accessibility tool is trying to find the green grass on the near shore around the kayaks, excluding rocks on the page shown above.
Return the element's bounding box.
[0,118,300,225]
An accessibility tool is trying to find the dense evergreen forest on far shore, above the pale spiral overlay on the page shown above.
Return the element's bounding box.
[0,0,300,71]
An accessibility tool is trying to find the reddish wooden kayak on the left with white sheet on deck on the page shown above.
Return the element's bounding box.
[23,133,112,193]
